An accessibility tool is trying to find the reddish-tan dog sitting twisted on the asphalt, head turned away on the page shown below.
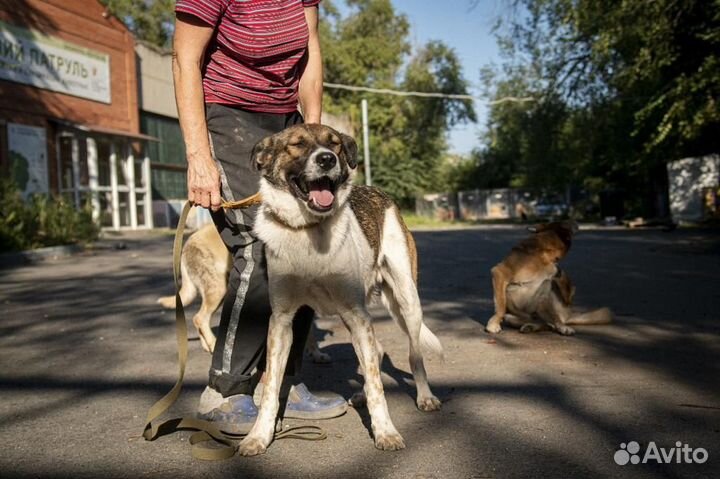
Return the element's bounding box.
[485,221,613,335]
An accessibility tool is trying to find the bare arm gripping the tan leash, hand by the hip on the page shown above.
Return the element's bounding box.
[173,13,220,210]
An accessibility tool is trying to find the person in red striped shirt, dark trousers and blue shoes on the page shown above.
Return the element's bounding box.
[173,0,347,433]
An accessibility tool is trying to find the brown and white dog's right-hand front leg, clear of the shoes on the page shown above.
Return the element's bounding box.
[340,309,405,451]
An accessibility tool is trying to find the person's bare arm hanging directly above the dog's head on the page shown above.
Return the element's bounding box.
[298,6,323,123]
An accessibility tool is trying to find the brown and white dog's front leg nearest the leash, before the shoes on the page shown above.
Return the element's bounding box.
[239,313,293,456]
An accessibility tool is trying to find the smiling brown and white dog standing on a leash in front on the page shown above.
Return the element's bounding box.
[239,124,442,456]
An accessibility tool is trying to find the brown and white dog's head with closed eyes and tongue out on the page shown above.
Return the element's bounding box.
[252,124,357,219]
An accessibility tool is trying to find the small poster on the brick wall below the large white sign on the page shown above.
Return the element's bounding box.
[7,123,49,198]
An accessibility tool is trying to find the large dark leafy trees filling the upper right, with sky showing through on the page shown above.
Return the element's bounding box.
[478,0,720,216]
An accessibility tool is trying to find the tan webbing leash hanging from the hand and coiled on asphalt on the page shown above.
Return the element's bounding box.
[142,193,327,461]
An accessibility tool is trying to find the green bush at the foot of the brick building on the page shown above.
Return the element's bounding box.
[0,179,100,251]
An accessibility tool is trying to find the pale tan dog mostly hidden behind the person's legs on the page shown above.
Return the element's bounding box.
[158,224,330,363]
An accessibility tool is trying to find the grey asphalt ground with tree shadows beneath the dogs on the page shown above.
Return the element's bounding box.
[0,228,720,478]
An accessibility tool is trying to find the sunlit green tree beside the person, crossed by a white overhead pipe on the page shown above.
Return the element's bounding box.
[321,0,475,206]
